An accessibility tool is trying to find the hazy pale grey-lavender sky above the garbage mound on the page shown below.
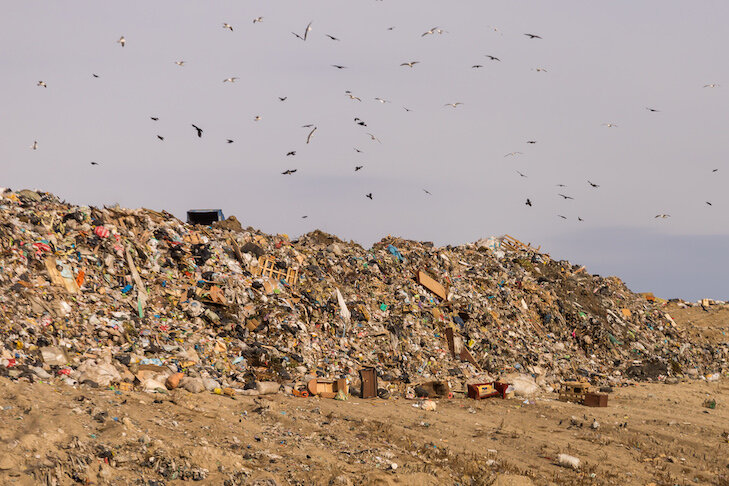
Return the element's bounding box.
[0,0,729,300]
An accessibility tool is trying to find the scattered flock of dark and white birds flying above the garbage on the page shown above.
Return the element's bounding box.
[30,10,720,222]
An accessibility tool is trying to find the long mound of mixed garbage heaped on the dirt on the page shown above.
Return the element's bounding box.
[0,190,727,396]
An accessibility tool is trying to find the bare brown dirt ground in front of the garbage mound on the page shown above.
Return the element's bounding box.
[0,378,729,485]
